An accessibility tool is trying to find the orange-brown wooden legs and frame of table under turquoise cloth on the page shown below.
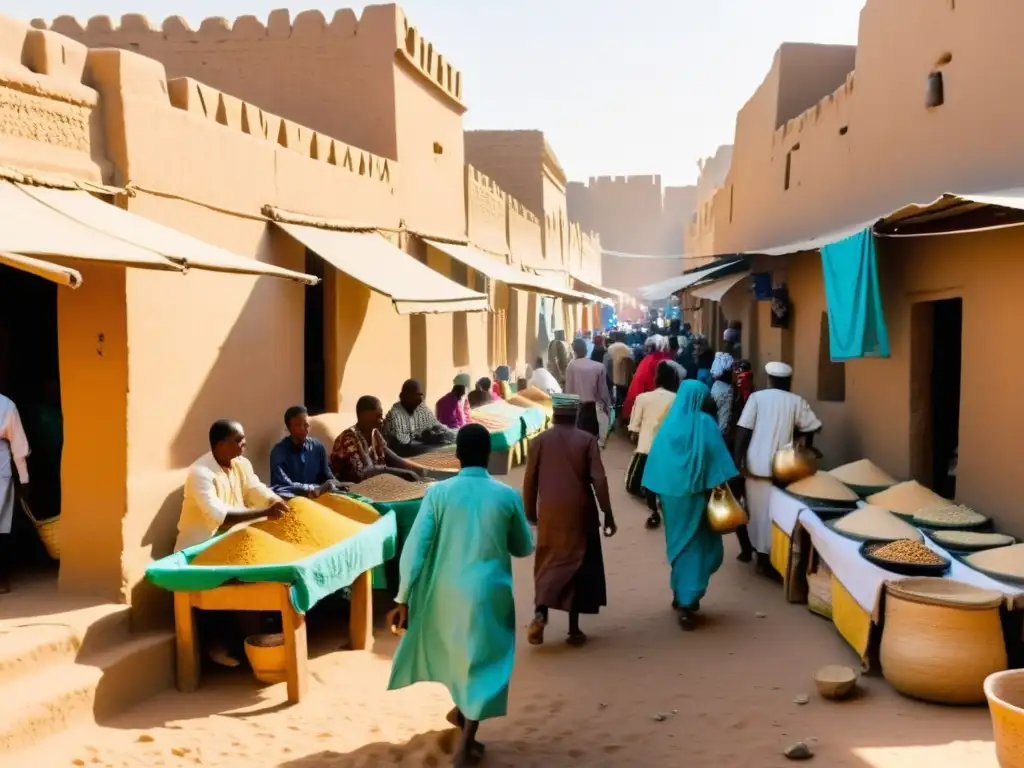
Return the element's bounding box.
[174,570,374,703]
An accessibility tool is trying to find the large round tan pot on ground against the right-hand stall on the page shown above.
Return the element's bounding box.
[880,579,1008,705]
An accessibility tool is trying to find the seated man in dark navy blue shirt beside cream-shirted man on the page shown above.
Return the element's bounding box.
[270,406,350,499]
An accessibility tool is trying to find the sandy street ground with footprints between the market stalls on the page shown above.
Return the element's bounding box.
[16,440,996,768]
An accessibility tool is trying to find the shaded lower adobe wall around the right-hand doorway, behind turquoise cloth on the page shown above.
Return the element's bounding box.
[765,229,1024,536]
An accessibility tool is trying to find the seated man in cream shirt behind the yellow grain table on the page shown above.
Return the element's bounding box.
[174,419,288,667]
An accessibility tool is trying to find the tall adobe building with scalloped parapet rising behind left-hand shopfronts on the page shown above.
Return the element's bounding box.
[33,4,465,237]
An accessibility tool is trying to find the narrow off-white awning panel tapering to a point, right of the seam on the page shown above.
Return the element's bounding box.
[18,186,317,285]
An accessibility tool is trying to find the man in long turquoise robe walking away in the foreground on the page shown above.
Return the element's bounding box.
[388,424,534,766]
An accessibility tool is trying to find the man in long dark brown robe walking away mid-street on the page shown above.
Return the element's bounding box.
[522,395,617,645]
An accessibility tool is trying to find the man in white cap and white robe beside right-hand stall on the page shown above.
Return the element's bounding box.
[734,361,821,568]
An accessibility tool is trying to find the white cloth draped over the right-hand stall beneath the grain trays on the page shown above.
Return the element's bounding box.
[798,501,1024,614]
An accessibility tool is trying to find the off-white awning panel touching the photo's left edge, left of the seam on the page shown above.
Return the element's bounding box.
[0,181,183,272]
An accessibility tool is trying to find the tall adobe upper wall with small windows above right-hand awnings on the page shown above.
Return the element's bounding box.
[700,0,1024,259]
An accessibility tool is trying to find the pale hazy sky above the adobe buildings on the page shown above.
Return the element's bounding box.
[18,0,863,183]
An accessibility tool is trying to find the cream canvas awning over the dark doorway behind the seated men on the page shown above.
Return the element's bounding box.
[273,221,489,314]
